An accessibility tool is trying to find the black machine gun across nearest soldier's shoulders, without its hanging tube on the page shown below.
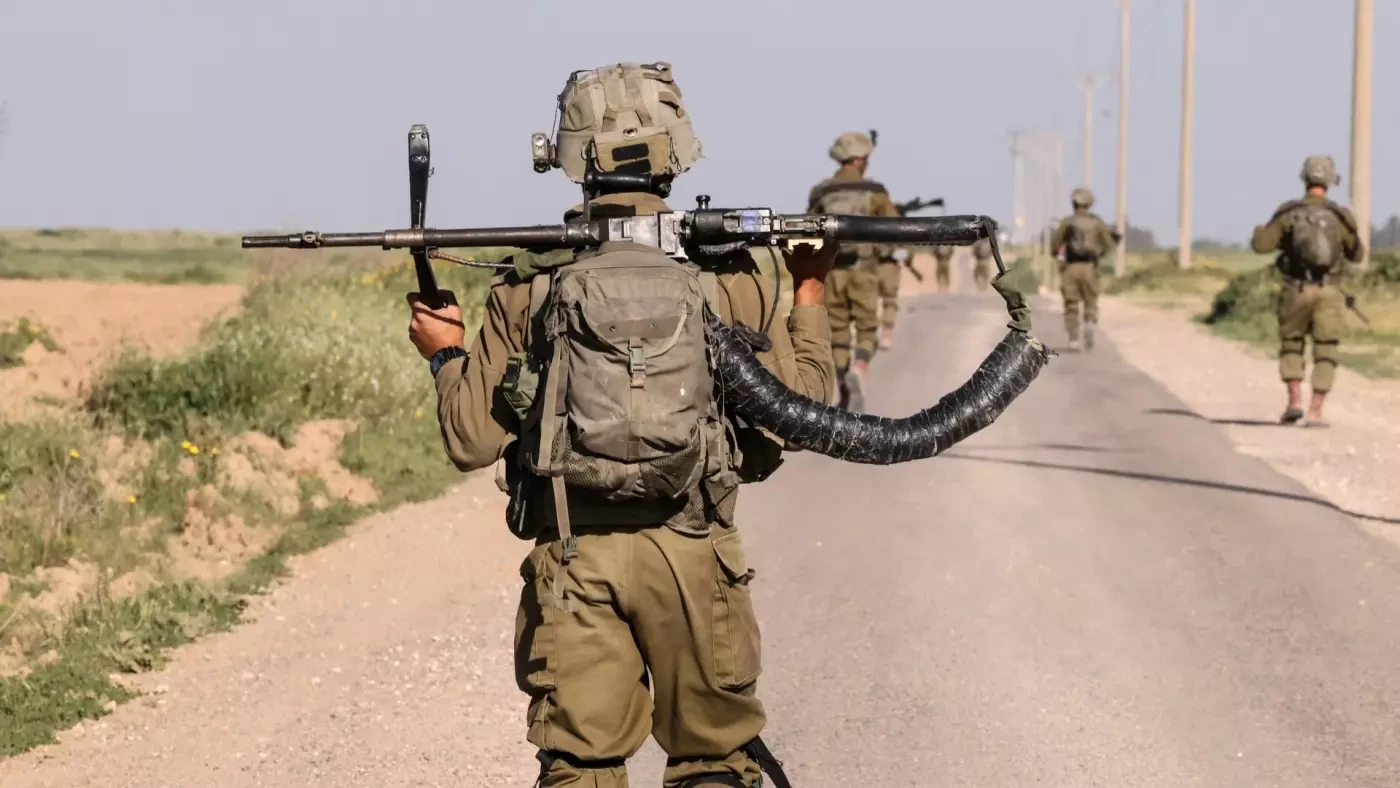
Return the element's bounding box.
[242,126,1005,275]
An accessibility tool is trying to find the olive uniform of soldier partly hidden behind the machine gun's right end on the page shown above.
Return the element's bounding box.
[808,158,899,374]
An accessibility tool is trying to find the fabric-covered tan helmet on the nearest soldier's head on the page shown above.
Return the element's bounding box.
[531,63,701,183]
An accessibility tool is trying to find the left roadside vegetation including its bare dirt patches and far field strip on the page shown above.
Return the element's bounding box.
[0,239,503,757]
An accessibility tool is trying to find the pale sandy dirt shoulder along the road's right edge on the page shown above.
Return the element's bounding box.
[1102,298,1400,543]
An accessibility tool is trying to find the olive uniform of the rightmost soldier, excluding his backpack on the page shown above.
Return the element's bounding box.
[1250,195,1362,393]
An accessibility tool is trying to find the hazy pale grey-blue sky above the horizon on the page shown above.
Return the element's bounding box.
[0,0,1400,241]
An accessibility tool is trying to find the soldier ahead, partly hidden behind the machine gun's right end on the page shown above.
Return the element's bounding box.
[808,132,899,411]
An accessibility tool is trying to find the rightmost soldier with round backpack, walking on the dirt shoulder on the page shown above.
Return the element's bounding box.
[1250,155,1364,425]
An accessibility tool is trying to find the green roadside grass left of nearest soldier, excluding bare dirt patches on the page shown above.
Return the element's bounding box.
[0,253,500,756]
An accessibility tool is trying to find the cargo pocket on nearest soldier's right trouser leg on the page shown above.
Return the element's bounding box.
[711,530,762,690]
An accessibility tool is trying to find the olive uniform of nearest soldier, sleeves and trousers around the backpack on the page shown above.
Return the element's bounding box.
[437,195,834,788]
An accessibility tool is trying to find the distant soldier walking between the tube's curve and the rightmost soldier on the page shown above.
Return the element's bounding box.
[1050,188,1117,351]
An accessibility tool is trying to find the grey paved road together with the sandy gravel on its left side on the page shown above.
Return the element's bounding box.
[0,294,1400,788]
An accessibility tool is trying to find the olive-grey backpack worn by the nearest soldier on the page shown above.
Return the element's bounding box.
[501,242,738,605]
